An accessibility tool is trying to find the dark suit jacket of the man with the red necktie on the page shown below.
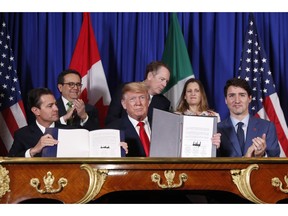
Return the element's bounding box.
[106,115,146,157]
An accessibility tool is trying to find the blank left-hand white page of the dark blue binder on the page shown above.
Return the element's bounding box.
[57,129,89,157]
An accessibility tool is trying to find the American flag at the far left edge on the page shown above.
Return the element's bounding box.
[0,18,27,156]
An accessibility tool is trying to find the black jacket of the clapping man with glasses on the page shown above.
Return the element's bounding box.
[57,97,100,131]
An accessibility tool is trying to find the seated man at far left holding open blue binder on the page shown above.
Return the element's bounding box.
[8,88,67,157]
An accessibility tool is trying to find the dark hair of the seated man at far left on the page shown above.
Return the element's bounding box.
[28,88,54,109]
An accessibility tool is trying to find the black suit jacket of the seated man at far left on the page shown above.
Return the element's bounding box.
[8,122,71,157]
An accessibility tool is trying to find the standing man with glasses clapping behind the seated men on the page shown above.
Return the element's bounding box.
[57,69,100,131]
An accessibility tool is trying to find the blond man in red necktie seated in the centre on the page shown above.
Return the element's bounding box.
[106,82,151,157]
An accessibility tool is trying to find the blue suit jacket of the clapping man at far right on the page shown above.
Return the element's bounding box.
[217,115,280,157]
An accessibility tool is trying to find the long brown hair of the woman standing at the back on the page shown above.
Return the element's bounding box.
[176,78,209,113]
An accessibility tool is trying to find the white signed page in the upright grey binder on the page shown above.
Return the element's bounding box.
[181,116,215,157]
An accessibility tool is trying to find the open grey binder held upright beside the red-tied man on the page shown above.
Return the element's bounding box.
[150,108,217,157]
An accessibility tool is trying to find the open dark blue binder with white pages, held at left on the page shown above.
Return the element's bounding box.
[42,128,125,157]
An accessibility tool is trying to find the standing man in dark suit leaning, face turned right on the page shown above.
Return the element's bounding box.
[105,61,170,125]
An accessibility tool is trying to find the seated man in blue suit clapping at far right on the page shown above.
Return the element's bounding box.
[217,78,280,157]
